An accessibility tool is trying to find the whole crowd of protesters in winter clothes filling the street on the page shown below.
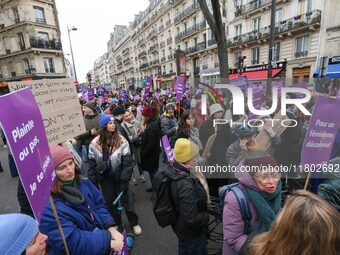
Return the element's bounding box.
[0,82,340,255]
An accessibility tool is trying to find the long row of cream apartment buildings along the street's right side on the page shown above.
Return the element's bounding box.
[95,0,340,88]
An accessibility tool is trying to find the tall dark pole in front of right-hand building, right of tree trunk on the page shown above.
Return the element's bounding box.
[267,0,276,95]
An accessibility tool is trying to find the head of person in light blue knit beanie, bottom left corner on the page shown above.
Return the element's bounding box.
[0,213,47,255]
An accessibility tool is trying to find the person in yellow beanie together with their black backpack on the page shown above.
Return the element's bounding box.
[153,138,209,255]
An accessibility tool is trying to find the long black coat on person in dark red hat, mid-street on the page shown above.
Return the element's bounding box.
[141,121,161,171]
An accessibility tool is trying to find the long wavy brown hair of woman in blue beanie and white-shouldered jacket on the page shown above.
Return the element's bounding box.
[98,125,123,154]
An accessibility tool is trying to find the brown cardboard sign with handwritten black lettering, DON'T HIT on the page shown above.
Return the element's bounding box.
[8,79,85,144]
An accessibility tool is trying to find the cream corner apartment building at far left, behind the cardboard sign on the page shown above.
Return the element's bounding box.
[0,0,67,94]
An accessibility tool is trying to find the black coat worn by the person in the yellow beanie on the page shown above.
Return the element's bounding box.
[165,163,209,240]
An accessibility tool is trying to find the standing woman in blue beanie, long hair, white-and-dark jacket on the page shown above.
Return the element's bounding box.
[89,114,142,235]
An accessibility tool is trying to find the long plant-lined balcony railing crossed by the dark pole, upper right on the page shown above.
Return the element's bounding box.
[227,10,321,47]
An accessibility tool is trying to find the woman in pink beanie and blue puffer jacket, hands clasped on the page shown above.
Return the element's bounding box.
[40,144,123,255]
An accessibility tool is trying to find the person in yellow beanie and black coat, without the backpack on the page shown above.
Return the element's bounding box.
[153,138,209,255]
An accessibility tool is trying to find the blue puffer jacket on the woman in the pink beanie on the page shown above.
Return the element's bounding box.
[40,180,115,255]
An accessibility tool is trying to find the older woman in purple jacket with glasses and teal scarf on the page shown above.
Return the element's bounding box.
[223,156,281,255]
